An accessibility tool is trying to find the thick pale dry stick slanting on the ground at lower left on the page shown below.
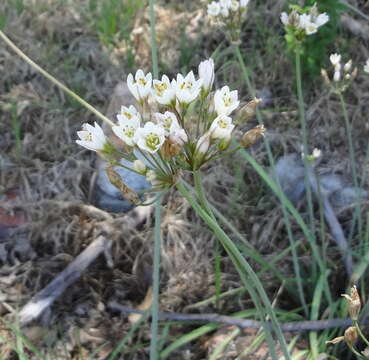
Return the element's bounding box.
[19,235,111,325]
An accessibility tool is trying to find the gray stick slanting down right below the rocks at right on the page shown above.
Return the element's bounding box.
[307,165,353,278]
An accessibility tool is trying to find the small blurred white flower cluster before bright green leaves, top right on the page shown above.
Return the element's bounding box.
[281,4,329,35]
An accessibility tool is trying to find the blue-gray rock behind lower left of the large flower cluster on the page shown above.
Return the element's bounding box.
[95,160,151,213]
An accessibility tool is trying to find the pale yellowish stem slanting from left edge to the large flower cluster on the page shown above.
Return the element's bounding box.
[0,30,115,126]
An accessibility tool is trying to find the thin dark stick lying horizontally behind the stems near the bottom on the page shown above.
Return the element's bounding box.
[108,301,369,332]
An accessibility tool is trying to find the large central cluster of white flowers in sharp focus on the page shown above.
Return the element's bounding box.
[77,59,250,190]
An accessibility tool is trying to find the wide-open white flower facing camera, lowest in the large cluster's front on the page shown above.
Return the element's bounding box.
[135,121,165,154]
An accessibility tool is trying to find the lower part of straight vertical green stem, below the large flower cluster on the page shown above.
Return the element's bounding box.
[150,197,161,360]
